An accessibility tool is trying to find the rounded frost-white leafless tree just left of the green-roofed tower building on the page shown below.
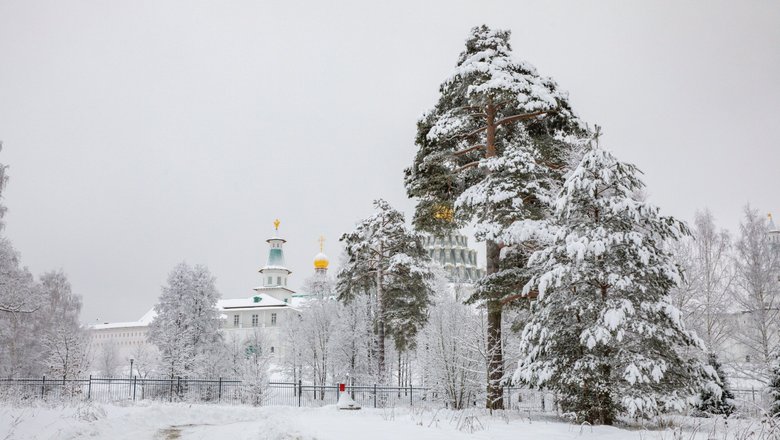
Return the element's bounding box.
[148,263,222,376]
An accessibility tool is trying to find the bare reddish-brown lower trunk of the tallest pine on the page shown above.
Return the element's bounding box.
[486,241,504,409]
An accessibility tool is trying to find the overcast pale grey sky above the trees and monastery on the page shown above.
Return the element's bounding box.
[0,0,780,322]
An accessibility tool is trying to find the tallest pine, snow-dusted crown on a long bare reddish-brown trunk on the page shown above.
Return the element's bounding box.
[405,25,582,409]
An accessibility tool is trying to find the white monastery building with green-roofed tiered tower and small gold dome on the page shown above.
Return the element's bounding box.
[90,220,329,372]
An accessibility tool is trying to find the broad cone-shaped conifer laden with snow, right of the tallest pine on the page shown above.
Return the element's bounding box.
[515,141,719,424]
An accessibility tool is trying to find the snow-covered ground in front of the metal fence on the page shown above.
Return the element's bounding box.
[0,402,768,440]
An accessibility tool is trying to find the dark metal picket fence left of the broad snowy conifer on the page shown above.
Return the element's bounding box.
[0,376,556,412]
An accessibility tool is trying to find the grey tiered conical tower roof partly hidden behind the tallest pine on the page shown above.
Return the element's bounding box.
[425,232,485,284]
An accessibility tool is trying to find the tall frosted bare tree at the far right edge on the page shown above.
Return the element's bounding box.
[734,206,780,382]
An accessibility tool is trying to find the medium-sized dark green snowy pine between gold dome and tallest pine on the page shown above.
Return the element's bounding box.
[336,199,432,383]
